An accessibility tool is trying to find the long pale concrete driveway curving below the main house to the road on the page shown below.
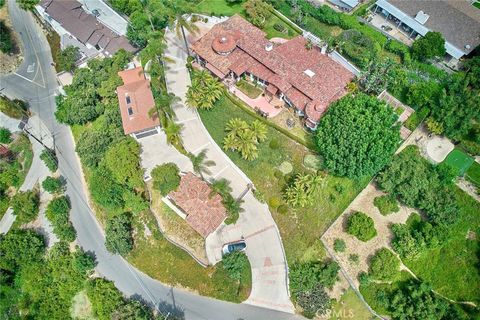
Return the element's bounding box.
[166,27,294,313]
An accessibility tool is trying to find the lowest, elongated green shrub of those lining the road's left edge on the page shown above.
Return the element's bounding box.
[45,196,77,242]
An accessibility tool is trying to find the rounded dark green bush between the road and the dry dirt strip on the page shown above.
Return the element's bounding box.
[105,213,133,256]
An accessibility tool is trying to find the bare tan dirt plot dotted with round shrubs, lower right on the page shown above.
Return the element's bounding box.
[322,182,415,288]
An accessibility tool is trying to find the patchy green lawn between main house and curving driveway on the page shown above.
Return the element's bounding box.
[200,97,368,263]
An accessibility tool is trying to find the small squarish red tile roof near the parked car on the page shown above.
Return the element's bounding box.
[169,172,227,238]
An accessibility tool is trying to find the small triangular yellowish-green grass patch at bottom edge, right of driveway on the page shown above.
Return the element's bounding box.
[330,289,372,320]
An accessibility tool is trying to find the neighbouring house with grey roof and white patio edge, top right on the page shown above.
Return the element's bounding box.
[373,0,480,61]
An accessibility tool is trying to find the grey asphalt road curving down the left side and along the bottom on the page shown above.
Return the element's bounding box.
[0,0,299,320]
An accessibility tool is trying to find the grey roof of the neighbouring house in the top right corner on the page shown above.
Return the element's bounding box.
[378,0,480,54]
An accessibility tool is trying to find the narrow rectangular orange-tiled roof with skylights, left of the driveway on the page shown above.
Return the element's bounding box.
[117,67,159,134]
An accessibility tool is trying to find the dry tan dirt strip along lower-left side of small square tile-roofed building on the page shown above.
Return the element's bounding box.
[149,184,208,264]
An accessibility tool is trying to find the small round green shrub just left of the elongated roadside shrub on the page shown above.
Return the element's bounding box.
[10,190,40,224]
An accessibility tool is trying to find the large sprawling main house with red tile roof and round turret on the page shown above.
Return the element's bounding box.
[191,15,354,129]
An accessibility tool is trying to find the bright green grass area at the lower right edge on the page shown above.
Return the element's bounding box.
[403,186,480,304]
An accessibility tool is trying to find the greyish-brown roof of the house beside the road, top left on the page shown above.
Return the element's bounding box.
[40,0,136,54]
